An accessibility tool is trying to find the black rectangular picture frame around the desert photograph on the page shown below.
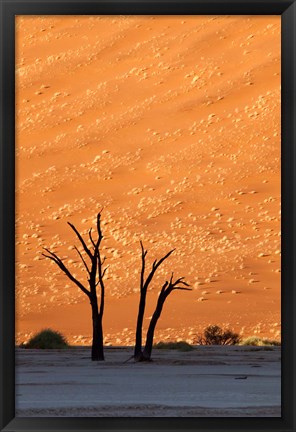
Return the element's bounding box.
[0,0,296,432]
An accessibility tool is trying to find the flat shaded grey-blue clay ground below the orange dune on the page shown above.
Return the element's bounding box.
[16,346,281,417]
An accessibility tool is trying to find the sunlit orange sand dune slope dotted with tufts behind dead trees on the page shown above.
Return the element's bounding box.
[16,16,281,346]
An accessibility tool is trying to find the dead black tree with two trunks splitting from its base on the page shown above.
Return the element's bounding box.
[133,241,191,361]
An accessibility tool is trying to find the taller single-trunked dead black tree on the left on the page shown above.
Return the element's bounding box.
[42,212,107,360]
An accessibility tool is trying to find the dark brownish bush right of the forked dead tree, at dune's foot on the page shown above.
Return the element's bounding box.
[197,325,240,345]
